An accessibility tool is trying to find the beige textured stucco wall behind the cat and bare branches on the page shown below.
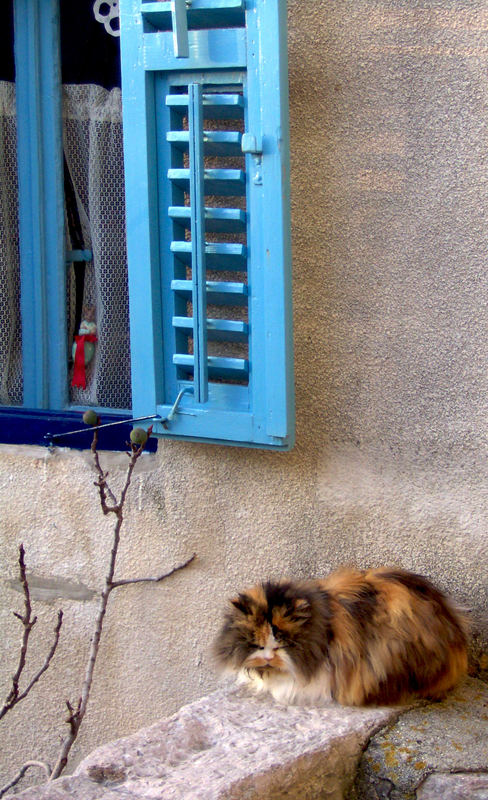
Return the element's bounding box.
[0,0,488,788]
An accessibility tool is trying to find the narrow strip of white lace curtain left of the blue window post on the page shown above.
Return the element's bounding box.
[0,81,22,405]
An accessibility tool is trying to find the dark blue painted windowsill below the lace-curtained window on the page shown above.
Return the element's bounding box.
[0,406,158,453]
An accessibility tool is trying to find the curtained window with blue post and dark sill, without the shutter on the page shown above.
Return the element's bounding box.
[0,0,146,449]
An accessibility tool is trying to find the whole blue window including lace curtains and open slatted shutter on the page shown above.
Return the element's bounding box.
[0,0,293,449]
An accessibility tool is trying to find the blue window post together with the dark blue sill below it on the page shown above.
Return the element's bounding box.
[0,0,157,451]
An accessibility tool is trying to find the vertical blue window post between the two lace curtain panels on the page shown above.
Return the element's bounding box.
[14,0,68,409]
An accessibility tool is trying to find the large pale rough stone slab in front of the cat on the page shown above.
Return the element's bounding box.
[9,689,400,800]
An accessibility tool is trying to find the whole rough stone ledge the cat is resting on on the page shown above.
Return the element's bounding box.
[11,678,488,800]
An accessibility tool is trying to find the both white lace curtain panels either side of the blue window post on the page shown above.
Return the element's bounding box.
[0,82,131,409]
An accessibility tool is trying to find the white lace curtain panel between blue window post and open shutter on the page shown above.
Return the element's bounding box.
[63,84,131,408]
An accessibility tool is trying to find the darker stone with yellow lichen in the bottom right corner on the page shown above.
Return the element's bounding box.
[351,678,488,800]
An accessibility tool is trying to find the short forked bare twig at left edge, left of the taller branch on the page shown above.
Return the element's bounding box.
[0,544,63,720]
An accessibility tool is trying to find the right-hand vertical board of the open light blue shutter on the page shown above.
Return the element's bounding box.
[247,0,294,437]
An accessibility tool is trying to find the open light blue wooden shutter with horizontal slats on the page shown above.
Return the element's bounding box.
[120,0,294,449]
